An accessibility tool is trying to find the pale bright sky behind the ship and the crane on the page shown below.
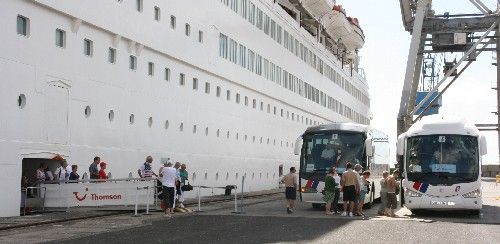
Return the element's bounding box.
[337,0,498,164]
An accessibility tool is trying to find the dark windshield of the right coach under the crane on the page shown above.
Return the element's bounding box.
[406,135,479,184]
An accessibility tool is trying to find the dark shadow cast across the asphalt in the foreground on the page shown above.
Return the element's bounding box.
[53,215,350,243]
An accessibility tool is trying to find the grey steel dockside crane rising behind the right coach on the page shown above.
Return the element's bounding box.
[397,0,500,156]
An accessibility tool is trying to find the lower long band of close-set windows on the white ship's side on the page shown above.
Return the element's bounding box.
[219,33,369,124]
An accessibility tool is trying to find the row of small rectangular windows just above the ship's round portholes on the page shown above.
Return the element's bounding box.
[13,16,332,125]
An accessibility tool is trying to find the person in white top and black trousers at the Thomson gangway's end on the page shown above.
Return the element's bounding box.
[160,163,178,218]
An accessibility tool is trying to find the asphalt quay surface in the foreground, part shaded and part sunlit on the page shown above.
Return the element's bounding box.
[52,215,500,243]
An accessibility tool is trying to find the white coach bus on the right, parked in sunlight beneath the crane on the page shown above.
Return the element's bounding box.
[397,116,486,213]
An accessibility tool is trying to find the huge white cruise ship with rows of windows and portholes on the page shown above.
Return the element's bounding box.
[0,0,371,216]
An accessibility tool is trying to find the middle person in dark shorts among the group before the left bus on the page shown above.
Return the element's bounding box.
[340,162,359,217]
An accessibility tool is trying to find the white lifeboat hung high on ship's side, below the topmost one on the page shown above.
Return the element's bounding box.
[321,5,353,40]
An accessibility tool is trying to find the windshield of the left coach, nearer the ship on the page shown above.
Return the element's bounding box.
[300,131,366,173]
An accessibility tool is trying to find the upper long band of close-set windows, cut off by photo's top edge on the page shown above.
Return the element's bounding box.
[221,0,370,106]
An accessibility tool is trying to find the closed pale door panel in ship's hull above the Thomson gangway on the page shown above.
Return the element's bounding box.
[44,81,69,144]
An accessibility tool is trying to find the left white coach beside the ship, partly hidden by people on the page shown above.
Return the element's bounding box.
[295,123,389,208]
